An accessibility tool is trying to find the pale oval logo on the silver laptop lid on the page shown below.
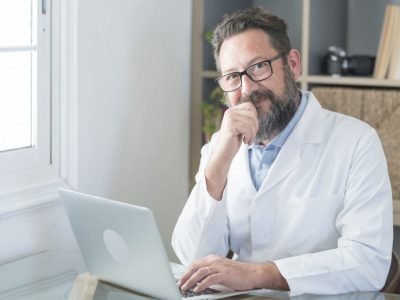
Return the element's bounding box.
[103,229,130,263]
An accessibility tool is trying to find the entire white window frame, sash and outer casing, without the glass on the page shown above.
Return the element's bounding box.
[0,0,78,205]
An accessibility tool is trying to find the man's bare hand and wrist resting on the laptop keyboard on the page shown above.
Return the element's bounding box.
[179,255,288,292]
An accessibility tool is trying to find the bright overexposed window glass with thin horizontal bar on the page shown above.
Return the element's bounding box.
[0,0,37,151]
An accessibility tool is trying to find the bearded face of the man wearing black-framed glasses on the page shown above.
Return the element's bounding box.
[219,30,298,142]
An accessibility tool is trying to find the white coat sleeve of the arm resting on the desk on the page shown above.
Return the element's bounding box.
[274,129,393,295]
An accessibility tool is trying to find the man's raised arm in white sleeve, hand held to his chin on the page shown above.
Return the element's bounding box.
[172,103,258,264]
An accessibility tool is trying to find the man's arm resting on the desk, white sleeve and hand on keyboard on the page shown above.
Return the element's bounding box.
[180,129,393,296]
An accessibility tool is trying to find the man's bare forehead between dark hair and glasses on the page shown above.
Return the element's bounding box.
[219,29,277,73]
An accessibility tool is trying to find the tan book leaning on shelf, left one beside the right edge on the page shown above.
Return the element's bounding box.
[374,4,399,79]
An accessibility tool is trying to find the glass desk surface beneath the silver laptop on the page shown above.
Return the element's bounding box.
[0,252,400,300]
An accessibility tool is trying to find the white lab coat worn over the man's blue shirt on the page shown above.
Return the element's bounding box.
[172,92,393,295]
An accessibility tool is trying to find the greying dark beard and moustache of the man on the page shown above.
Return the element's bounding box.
[240,66,298,143]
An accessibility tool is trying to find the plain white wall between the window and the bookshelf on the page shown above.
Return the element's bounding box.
[77,0,191,260]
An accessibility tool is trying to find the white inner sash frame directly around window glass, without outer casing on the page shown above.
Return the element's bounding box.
[0,0,54,191]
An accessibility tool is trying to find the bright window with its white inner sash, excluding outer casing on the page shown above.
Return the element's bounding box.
[0,0,55,191]
